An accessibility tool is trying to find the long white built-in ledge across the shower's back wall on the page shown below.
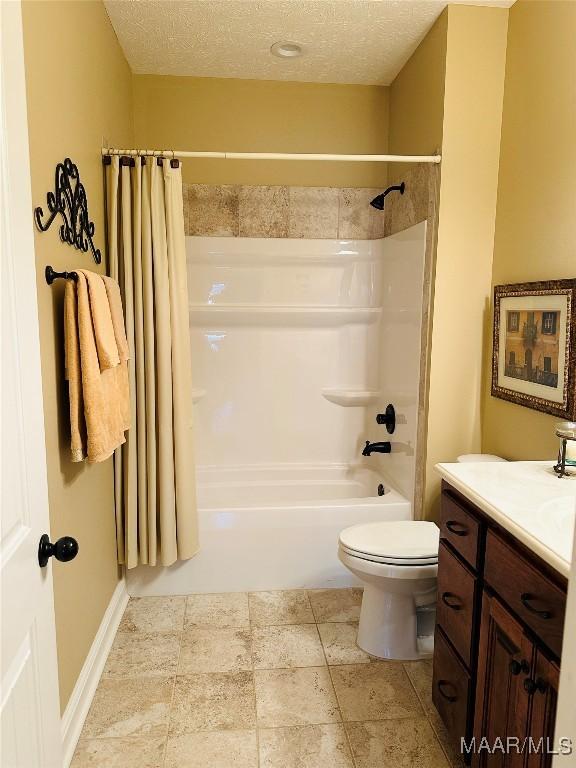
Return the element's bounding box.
[189,304,381,327]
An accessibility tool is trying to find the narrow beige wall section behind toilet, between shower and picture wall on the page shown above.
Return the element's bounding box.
[424,5,508,517]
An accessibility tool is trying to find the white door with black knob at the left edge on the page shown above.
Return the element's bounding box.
[0,0,62,768]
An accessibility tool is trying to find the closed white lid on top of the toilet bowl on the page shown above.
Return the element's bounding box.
[340,520,440,562]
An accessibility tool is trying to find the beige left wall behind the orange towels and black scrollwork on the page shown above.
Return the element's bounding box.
[23,0,133,709]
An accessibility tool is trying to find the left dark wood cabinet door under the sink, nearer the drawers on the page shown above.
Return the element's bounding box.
[472,593,534,768]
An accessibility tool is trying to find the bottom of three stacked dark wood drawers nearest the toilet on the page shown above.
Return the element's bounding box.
[432,627,470,745]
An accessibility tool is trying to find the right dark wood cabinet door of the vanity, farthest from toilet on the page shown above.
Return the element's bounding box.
[526,651,560,768]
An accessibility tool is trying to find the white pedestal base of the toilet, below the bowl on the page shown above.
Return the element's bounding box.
[357,584,431,661]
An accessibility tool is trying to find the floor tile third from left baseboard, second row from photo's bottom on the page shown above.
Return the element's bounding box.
[254,667,341,728]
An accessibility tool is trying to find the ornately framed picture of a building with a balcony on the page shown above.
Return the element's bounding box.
[492,279,576,421]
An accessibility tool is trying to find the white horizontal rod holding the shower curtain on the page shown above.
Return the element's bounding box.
[102,148,442,163]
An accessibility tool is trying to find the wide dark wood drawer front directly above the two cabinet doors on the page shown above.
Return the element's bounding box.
[484,531,566,658]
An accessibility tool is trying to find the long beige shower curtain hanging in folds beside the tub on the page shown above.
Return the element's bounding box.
[106,157,198,568]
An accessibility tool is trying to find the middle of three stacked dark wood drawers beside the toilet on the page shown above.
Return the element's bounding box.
[436,542,476,666]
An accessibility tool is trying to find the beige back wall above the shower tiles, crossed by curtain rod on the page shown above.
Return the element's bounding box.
[133,75,388,187]
